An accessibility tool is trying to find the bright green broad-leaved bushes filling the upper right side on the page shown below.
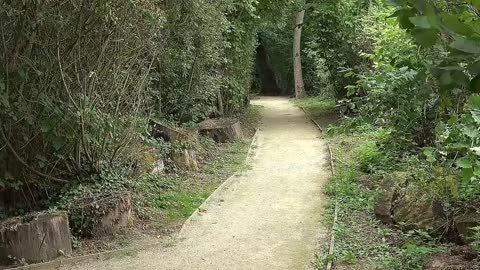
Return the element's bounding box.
[328,1,480,204]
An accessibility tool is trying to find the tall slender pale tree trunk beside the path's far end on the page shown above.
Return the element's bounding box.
[293,10,305,98]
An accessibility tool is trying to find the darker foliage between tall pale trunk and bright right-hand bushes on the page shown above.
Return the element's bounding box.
[303,0,368,98]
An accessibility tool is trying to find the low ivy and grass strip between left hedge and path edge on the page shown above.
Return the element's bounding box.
[52,106,261,252]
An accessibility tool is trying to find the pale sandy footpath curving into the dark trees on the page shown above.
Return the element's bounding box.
[65,97,329,270]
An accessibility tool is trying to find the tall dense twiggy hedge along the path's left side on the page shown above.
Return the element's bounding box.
[0,0,291,215]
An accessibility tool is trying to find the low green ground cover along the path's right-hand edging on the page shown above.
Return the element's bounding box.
[297,100,445,270]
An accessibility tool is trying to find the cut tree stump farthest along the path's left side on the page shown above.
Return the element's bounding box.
[199,118,242,143]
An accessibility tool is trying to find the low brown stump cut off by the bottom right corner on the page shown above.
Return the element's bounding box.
[423,246,480,270]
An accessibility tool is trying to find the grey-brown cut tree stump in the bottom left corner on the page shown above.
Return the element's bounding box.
[0,212,72,263]
